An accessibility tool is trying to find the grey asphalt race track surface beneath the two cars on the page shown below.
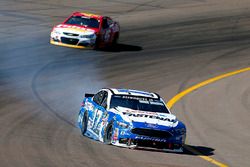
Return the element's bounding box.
[0,0,250,167]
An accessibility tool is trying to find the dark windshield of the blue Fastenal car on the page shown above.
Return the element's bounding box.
[110,95,169,113]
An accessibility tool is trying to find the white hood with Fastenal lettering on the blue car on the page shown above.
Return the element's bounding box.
[111,107,178,128]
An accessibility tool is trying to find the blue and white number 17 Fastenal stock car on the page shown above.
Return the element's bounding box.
[77,88,186,152]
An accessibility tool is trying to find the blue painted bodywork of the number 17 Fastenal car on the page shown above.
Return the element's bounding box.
[78,89,186,150]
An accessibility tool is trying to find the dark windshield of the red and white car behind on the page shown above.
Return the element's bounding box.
[65,16,99,28]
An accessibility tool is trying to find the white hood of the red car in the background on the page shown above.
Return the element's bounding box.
[53,24,96,35]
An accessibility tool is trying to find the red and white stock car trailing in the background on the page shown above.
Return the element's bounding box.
[50,12,120,49]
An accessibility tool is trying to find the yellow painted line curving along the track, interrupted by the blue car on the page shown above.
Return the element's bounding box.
[167,67,250,167]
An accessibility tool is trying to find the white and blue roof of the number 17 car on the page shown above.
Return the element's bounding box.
[109,88,159,99]
